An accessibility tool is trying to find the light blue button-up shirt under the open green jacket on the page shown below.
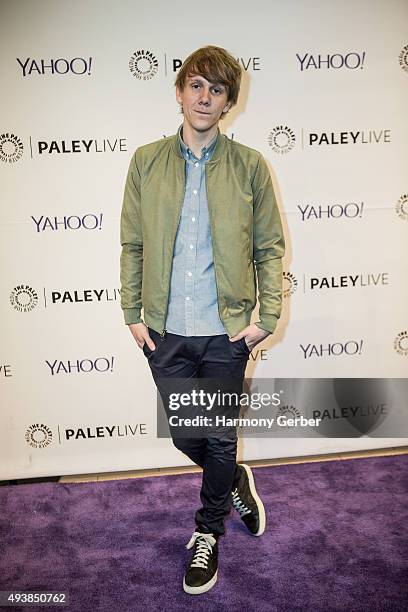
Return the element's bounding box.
[165,125,227,336]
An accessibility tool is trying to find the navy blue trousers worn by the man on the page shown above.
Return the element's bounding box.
[143,328,250,535]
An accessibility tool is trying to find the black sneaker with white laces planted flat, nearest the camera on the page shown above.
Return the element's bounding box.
[183,531,218,595]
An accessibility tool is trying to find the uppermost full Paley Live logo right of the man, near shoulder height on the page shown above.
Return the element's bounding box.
[267,125,391,155]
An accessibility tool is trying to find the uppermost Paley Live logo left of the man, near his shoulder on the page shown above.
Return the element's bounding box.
[0,132,127,164]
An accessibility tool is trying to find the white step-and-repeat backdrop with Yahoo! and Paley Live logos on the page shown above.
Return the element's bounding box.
[0,0,408,479]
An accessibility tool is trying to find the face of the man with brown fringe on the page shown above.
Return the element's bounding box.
[176,74,231,132]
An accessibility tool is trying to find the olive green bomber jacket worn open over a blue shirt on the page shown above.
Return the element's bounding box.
[120,133,285,336]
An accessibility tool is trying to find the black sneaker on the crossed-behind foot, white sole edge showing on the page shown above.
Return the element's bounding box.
[232,463,266,535]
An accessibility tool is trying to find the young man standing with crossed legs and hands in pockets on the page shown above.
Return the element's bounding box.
[121,46,284,594]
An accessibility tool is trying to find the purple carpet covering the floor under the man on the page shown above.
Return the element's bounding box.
[0,455,408,612]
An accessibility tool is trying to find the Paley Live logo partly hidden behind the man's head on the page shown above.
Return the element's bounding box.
[129,49,262,81]
